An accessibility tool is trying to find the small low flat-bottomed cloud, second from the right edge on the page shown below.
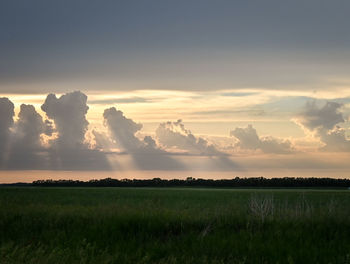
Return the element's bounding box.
[230,125,293,154]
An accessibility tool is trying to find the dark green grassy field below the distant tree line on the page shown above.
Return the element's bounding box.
[0,187,350,264]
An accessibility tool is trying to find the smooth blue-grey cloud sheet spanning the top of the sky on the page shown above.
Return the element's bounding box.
[0,0,350,92]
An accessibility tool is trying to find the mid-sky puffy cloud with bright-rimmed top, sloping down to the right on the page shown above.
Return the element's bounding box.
[156,119,224,155]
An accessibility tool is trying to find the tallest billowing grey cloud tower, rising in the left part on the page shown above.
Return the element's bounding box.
[41,91,89,148]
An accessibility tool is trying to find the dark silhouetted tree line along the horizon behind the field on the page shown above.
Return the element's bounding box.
[26,177,350,188]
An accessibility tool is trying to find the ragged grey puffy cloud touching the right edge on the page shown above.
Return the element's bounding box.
[294,101,350,151]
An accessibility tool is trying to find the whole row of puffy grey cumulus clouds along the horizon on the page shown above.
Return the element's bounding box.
[0,91,350,171]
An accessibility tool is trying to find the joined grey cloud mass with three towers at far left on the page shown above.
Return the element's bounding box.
[0,92,110,170]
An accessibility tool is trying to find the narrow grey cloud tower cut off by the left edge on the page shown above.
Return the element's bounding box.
[0,98,15,166]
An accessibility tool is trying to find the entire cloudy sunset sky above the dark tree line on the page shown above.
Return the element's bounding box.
[0,0,350,182]
